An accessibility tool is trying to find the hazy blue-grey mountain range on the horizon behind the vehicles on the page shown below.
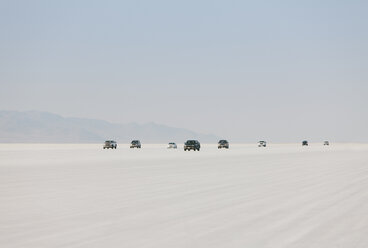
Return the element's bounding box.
[0,111,218,143]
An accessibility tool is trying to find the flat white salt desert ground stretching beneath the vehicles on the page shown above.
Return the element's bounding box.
[0,143,368,248]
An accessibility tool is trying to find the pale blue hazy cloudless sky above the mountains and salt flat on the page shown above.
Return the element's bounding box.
[0,0,368,142]
